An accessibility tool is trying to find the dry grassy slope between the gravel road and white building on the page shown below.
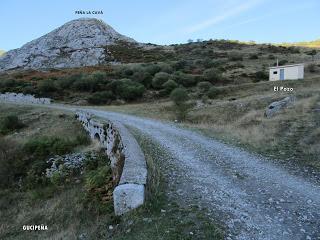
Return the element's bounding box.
[99,78,320,169]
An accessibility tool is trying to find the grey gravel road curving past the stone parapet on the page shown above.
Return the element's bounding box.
[80,110,320,240]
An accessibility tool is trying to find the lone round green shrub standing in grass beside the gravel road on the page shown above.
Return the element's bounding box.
[170,88,192,121]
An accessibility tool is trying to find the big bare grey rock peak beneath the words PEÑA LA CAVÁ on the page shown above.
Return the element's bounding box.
[0,18,135,72]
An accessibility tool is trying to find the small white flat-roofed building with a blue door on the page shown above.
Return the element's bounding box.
[269,63,304,81]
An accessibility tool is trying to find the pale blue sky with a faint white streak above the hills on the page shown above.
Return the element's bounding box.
[0,0,320,51]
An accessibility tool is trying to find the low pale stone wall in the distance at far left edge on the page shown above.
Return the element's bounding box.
[0,92,51,104]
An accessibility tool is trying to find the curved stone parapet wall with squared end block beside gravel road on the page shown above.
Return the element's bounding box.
[76,111,147,215]
